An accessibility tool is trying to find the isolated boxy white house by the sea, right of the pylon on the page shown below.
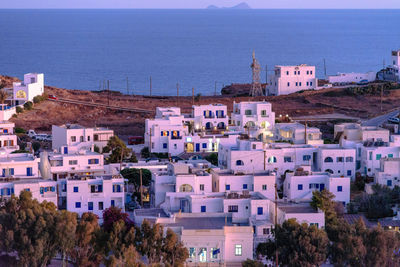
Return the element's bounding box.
[267,64,318,95]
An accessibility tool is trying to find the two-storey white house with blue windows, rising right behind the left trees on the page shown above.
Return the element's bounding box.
[63,174,125,219]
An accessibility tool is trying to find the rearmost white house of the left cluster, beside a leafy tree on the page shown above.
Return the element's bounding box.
[51,124,114,150]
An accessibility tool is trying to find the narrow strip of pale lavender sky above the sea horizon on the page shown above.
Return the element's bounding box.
[0,0,400,9]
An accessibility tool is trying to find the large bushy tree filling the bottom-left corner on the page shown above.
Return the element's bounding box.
[0,191,63,266]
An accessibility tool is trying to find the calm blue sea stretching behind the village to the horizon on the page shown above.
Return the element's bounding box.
[0,10,400,95]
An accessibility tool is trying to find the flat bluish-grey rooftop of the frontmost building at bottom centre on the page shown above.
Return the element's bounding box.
[164,217,236,230]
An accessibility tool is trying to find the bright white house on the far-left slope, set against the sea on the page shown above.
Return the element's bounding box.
[12,73,44,105]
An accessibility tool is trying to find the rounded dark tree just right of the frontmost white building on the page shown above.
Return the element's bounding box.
[258,219,329,267]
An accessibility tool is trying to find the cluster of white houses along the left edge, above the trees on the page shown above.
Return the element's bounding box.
[0,121,125,219]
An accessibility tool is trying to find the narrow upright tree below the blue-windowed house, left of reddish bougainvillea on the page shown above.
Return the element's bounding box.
[68,213,103,267]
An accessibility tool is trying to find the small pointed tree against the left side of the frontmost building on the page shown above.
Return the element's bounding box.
[162,228,189,267]
